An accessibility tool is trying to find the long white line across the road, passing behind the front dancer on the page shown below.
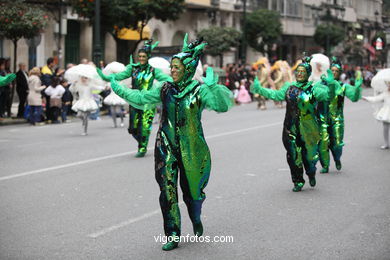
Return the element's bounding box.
[0,122,282,182]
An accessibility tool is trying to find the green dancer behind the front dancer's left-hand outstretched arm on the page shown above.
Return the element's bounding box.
[98,40,172,157]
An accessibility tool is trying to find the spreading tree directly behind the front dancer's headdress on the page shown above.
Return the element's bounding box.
[198,26,241,66]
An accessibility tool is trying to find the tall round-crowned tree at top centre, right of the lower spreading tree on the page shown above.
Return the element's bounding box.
[244,9,282,53]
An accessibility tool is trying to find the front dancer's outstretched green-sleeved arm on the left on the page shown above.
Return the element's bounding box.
[111,78,163,110]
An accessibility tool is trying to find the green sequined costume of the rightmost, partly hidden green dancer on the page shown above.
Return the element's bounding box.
[318,63,362,173]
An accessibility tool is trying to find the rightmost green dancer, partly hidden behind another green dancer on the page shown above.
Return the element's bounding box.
[320,57,363,173]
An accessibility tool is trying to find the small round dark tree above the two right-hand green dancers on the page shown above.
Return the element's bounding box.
[314,24,345,54]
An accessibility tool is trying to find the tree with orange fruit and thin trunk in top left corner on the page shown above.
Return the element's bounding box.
[0,0,49,71]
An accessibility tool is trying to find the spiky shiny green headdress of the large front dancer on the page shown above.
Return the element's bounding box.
[172,34,207,82]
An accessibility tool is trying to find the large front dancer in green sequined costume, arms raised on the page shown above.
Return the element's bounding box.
[107,35,233,250]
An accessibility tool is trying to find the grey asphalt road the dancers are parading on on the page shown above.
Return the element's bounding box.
[0,90,390,259]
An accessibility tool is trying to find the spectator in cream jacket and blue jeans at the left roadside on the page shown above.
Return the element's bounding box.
[27,67,46,125]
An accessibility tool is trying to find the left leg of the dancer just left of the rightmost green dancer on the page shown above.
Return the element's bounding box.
[283,131,305,191]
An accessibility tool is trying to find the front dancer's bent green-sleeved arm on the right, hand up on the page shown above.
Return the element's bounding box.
[200,67,233,112]
